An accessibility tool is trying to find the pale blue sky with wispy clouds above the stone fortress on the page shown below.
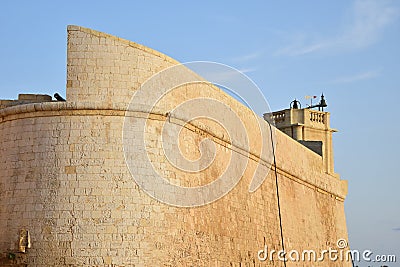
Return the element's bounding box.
[0,0,400,266]
